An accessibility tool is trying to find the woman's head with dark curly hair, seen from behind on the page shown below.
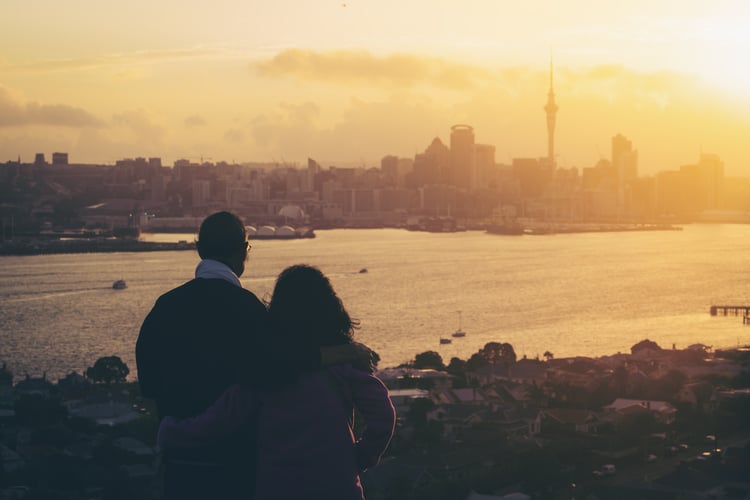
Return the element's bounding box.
[268,264,357,346]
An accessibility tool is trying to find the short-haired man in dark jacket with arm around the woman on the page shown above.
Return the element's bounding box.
[136,212,369,499]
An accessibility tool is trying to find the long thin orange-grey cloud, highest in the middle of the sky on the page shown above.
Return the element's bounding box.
[253,49,493,89]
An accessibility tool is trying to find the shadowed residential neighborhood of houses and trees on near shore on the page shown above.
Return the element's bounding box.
[0,340,750,500]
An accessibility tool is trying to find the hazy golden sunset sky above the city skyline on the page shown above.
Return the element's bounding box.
[0,0,750,176]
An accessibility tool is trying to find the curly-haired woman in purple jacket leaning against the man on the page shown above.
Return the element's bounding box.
[158,265,395,500]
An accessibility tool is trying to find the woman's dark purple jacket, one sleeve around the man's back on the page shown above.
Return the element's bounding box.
[157,365,396,500]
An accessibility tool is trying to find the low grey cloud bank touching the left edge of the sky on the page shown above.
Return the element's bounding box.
[0,86,102,127]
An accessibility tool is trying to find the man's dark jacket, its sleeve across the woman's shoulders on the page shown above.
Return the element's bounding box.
[136,278,320,471]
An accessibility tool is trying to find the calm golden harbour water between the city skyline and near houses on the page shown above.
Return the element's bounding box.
[0,225,750,380]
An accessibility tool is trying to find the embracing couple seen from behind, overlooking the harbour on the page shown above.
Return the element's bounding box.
[136,212,395,500]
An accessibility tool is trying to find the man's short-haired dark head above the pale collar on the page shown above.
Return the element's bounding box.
[196,212,248,276]
